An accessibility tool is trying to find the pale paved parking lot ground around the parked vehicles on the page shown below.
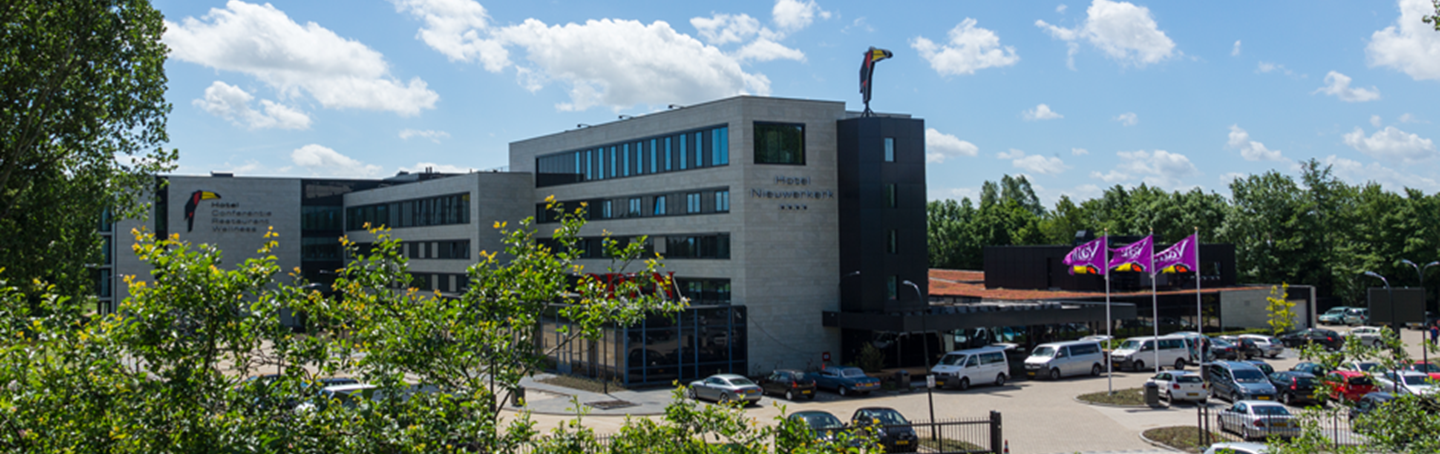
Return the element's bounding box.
[512,327,1423,454]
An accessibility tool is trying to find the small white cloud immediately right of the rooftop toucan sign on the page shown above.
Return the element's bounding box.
[910,17,1020,75]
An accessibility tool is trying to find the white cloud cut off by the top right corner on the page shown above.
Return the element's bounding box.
[1365,0,1440,81]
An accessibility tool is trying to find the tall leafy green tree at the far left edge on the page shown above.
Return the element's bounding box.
[0,0,176,310]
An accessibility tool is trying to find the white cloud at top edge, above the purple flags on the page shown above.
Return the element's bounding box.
[1035,0,1176,69]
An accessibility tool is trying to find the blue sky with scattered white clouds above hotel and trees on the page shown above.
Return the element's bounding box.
[154,0,1440,205]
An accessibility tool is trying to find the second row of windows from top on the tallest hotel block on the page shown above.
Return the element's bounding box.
[536,189,730,223]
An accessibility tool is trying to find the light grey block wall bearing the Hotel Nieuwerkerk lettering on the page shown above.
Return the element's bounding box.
[510,97,847,372]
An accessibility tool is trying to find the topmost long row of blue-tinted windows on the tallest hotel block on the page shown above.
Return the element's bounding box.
[536,127,730,187]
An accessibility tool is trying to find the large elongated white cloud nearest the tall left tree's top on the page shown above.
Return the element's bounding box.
[163,0,439,115]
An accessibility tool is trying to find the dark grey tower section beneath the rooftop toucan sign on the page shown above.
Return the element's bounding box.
[838,117,930,313]
